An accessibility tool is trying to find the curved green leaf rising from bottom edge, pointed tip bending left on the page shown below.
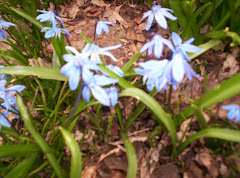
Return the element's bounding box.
[59,127,82,178]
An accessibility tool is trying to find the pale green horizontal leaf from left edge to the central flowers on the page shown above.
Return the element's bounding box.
[0,66,68,81]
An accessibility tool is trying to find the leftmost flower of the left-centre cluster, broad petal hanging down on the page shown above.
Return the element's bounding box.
[60,46,100,91]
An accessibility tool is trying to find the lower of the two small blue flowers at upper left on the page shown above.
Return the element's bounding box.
[41,26,72,39]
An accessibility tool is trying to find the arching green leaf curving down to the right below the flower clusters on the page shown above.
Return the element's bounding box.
[119,88,177,155]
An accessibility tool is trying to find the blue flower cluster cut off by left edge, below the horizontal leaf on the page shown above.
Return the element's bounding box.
[0,67,25,131]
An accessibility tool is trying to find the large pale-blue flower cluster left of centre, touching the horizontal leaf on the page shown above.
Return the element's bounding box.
[60,43,124,106]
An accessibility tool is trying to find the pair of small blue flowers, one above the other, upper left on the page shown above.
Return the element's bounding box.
[36,10,72,39]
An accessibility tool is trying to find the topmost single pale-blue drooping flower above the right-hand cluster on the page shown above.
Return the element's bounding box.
[142,4,177,31]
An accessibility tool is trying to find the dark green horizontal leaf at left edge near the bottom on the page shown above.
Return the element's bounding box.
[0,143,41,157]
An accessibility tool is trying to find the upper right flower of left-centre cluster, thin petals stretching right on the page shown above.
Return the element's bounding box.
[82,43,122,64]
